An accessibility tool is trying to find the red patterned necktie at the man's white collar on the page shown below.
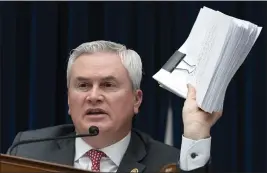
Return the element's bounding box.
[87,149,107,172]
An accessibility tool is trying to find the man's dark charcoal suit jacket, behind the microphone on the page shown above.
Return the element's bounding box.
[8,125,211,173]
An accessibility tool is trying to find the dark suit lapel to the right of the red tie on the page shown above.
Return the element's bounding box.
[117,132,146,173]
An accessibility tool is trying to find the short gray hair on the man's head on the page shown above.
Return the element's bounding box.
[67,40,142,90]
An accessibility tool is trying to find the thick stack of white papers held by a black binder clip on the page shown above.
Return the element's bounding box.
[153,7,262,113]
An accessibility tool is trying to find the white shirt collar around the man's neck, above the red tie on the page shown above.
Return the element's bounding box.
[74,132,131,166]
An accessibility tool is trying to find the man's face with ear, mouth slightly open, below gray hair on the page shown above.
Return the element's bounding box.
[68,53,142,134]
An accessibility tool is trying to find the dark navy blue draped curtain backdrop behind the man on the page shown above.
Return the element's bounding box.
[0,1,267,172]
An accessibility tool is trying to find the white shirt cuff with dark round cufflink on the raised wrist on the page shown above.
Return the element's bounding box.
[180,136,211,171]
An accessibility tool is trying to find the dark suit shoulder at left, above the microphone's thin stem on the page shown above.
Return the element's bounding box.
[20,124,74,140]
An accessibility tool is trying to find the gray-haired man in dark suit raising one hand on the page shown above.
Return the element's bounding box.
[9,41,221,172]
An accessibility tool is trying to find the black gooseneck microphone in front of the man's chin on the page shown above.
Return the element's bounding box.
[9,126,99,154]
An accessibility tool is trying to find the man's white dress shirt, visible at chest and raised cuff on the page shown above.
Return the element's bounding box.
[74,133,211,172]
